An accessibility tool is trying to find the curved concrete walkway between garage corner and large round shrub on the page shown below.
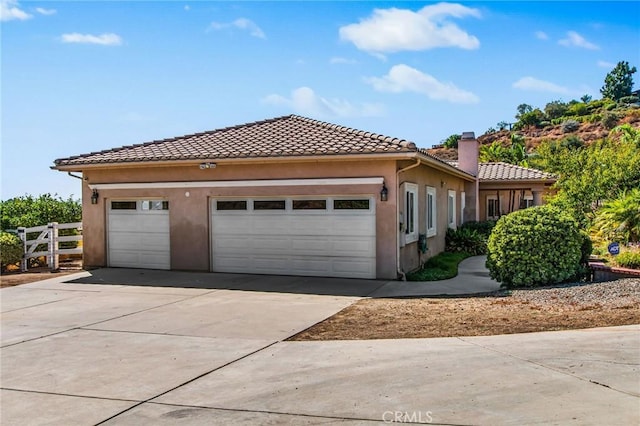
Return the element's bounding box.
[369,256,500,297]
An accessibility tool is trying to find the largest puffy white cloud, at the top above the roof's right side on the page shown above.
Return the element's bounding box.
[340,3,480,53]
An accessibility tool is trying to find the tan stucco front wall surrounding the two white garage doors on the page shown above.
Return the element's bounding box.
[83,160,397,279]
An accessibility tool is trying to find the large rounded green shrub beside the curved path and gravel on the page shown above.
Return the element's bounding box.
[487,206,584,287]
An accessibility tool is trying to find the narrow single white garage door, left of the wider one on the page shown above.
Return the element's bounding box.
[107,200,171,269]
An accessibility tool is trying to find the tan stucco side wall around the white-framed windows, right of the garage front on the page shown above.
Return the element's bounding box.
[399,164,465,273]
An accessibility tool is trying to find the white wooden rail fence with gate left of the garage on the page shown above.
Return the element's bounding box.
[18,222,82,272]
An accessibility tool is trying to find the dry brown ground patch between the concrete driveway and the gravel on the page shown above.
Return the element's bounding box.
[291,296,640,340]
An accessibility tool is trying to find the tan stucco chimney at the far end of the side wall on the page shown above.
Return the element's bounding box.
[458,132,480,222]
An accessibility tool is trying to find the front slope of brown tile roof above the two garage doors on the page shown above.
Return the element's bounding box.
[54,115,418,167]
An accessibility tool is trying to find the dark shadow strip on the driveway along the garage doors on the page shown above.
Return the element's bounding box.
[66,268,388,297]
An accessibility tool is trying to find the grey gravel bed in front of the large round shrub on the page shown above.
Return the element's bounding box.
[511,278,640,309]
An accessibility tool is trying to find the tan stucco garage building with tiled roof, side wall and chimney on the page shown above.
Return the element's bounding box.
[53,115,556,279]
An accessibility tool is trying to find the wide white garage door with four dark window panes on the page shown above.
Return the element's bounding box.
[211,196,376,278]
